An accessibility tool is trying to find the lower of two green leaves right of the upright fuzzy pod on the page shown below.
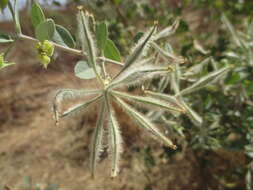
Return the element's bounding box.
[104,39,121,62]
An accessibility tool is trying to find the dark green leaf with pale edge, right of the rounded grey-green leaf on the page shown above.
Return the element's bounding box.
[53,24,76,48]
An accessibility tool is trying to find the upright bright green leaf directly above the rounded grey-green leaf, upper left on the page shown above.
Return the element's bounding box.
[31,2,46,28]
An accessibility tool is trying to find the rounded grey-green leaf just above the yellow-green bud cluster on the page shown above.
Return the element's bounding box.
[35,19,55,41]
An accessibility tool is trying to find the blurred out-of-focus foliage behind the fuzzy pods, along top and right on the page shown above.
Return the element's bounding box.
[1,0,253,190]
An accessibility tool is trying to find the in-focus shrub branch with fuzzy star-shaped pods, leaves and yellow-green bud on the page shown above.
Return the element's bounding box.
[0,0,230,177]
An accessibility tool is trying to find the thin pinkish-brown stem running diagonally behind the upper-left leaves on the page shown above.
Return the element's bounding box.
[18,34,124,66]
